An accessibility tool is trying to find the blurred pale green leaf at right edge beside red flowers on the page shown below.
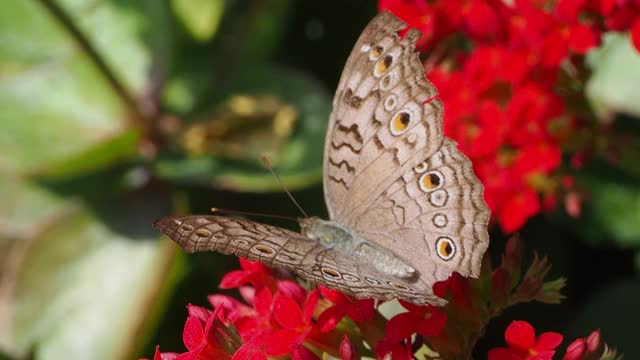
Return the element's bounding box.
[586,33,640,119]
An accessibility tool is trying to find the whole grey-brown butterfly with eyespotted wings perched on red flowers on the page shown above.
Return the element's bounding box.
[154,12,489,305]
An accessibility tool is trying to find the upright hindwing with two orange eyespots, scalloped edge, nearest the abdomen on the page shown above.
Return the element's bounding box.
[353,138,490,292]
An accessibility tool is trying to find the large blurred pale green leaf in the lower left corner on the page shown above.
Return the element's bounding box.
[0,177,182,359]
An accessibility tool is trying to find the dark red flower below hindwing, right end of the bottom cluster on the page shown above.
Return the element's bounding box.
[385,300,447,341]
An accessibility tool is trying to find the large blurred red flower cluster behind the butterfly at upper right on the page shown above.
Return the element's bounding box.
[378,0,640,232]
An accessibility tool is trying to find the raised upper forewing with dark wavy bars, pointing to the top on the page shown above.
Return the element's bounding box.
[324,12,443,225]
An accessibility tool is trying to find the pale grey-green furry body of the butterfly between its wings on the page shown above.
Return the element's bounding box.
[298,217,415,278]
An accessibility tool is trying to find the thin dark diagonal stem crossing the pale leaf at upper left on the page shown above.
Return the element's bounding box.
[38,0,148,129]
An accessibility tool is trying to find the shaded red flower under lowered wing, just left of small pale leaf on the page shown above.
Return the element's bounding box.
[318,285,375,332]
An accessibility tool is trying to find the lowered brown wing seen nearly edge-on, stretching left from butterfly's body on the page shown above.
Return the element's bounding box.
[153,215,445,304]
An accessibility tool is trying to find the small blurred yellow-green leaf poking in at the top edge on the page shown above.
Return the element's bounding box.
[171,0,224,41]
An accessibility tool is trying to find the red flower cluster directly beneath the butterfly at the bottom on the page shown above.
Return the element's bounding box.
[144,259,447,360]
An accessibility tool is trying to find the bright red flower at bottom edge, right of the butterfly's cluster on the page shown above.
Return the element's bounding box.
[489,321,562,360]
